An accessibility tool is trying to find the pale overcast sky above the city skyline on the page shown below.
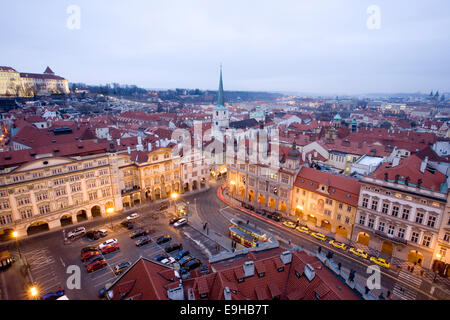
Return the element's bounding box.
[0,0,450,94]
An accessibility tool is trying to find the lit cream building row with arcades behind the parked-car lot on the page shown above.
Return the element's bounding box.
[0,142,209,236]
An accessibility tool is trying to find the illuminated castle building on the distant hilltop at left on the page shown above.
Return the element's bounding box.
[0,66,70,97]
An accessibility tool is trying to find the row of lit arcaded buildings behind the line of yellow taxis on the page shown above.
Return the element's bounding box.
[227,147,450,267]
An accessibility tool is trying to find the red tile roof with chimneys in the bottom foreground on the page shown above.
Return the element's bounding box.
[106,248,358,300]
